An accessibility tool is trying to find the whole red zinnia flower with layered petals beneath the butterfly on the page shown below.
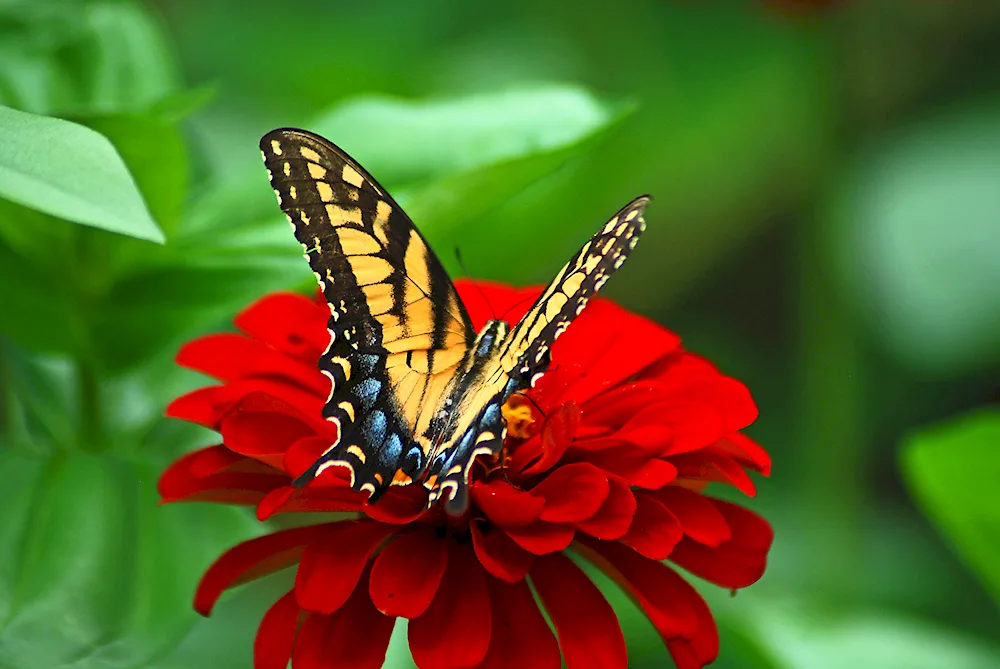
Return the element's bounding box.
[160,283,772,669]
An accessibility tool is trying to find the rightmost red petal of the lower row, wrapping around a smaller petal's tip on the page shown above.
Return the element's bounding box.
[670,498,774,588]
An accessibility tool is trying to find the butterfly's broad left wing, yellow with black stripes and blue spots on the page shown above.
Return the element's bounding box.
[260,129,474,500]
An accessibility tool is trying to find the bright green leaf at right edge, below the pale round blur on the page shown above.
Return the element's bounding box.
[902,409,1000,604]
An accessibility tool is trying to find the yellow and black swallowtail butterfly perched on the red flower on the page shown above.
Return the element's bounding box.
[260,128,649,515]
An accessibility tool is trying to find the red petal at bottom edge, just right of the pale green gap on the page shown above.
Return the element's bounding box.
[408,543,492,669]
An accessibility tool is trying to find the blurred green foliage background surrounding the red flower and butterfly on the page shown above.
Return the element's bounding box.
[0,0,1000,669]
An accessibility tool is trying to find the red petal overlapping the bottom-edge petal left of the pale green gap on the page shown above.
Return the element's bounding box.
[295,521,396,614]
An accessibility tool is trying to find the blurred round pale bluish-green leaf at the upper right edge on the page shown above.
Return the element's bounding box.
[828,100,1000,375]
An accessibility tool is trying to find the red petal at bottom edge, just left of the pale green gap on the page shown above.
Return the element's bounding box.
[292,574,396,669]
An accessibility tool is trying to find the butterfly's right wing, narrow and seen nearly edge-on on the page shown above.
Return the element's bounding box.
[426,196,650,514]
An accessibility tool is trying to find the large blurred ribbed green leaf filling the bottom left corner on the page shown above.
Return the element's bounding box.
[0,448,256,669]
